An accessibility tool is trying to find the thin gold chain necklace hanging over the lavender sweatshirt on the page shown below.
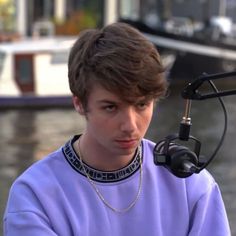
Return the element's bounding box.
[78,139,143,213]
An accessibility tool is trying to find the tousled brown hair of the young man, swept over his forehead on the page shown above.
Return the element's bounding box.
[68,23,167,108]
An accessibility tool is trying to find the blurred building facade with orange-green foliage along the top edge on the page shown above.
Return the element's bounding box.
[0,0,236,37]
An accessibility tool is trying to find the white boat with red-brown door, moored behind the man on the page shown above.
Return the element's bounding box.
[0,37,75,108]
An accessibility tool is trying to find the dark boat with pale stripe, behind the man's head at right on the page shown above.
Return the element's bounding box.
[119,16,236,80]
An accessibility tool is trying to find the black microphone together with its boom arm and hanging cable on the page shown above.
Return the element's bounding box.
[153,71,230,178]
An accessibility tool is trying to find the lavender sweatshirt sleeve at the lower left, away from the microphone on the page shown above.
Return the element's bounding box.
[3,168,57,236]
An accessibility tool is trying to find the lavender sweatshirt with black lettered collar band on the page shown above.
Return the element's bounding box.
[4,137,230,236]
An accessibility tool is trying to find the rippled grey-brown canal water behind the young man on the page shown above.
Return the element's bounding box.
[0,81,236,236]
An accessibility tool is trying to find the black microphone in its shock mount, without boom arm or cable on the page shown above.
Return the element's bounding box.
[153,100,204,178]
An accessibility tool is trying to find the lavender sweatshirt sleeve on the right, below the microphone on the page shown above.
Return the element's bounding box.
[189,183,231,236]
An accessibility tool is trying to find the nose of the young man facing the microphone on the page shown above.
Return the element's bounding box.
[120,107,137,133]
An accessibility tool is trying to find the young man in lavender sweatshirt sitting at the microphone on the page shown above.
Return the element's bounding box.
[4,23,230,236]
